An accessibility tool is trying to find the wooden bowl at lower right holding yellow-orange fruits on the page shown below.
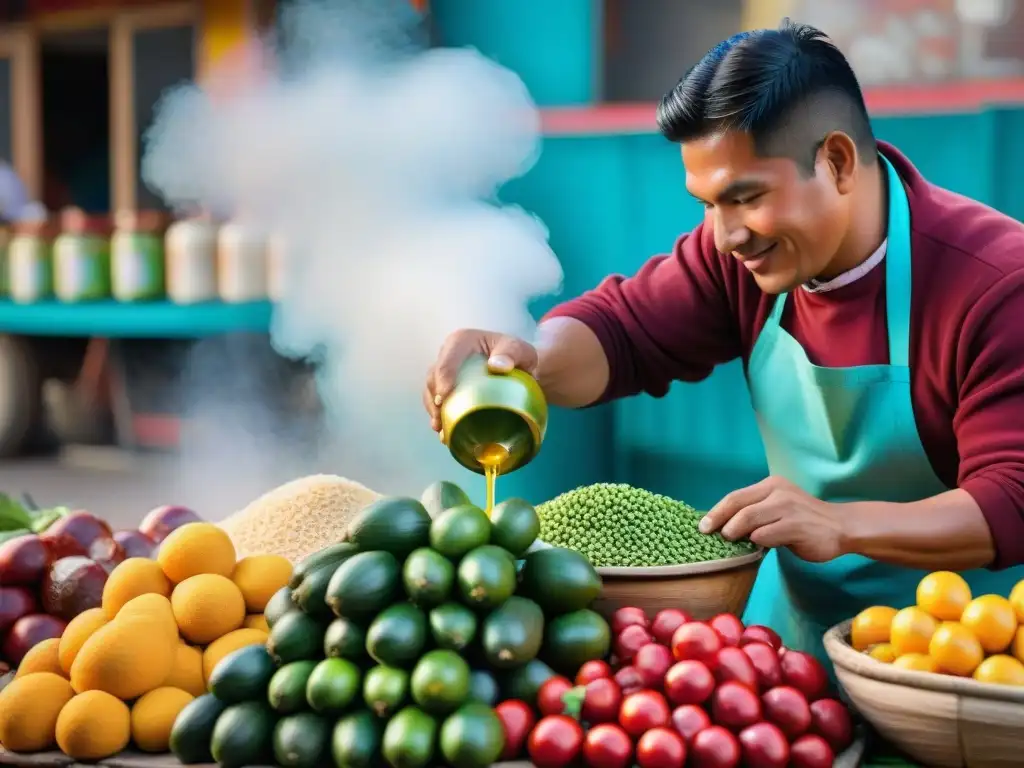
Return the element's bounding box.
[824,622,1024,768]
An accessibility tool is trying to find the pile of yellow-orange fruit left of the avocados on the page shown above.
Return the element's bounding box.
[0,520,292,760]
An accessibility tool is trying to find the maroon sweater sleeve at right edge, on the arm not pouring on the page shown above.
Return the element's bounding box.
[953,271,1024,568]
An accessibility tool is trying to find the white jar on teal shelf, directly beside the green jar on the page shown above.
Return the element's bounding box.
[164,216,217,304]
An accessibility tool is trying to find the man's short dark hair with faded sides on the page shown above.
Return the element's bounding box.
[657,18,877,173]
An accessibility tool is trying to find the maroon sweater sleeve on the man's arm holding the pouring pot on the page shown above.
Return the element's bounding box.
[546,225,742,401]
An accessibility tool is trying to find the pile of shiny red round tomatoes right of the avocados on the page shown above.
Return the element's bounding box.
[497,607,853,768]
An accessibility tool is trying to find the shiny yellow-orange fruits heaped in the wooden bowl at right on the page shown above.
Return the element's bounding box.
[850,570,1024,686]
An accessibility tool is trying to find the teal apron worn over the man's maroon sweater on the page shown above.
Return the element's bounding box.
[743,156,1024,662]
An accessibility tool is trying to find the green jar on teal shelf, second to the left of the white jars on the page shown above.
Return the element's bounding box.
[53,209,111,303]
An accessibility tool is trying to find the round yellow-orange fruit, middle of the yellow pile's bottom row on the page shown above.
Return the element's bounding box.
[57,690,131,760]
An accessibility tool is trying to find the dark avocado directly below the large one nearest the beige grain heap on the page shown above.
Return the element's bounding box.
[327,551,401,622]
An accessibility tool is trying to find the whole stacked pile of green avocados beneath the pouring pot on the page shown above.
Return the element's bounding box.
[165,483,610,768]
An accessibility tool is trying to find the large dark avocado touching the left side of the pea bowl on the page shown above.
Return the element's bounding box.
[517,547,601,615]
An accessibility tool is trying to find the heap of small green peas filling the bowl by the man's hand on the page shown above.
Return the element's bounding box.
[537,482,755,567]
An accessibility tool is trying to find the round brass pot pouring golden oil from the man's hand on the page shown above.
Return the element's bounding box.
[441,355,548,475]
